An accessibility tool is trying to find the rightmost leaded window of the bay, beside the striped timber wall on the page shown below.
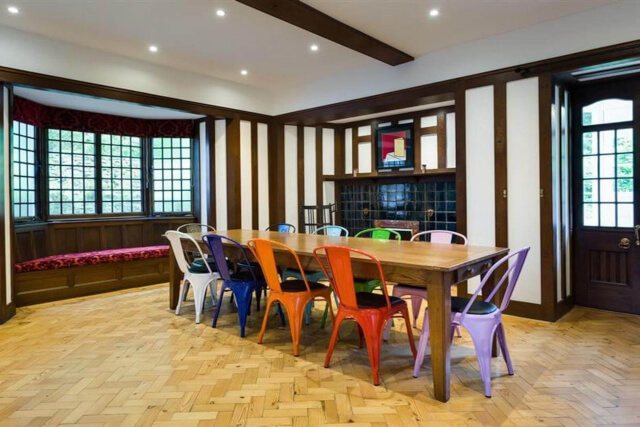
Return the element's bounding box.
[151,138,192,213]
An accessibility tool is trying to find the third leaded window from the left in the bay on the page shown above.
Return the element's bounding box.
[100,135,142,213]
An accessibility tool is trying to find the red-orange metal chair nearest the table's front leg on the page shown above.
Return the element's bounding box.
[313,246,416,385]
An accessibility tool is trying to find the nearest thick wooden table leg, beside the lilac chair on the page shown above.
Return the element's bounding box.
[429,277,452,402]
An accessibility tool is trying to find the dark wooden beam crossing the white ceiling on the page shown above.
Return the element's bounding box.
[237,0,414,66]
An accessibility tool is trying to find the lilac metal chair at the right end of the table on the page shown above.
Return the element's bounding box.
[413,247,531,397]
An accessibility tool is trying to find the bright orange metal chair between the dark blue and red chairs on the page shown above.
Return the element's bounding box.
[247,239,334,356]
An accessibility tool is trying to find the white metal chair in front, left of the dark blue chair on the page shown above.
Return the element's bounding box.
[165,230,220,323]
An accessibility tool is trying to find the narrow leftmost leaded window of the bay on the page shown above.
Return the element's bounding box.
[12,121,36,219]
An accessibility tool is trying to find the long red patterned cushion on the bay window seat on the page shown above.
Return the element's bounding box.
[15,246,169,273]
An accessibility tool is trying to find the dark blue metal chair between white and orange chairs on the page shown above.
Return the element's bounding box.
[202,234,267,337]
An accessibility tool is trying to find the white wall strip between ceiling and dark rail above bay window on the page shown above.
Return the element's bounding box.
[0,25,273,114]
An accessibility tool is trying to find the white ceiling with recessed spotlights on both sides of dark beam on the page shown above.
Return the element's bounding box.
[0,0,614,90]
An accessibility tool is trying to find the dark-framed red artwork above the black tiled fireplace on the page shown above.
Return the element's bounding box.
[376,123,414,170]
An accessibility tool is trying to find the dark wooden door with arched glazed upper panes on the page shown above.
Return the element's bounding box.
[572,77,640,313]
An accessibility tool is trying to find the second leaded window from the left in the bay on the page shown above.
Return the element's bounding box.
[47,129,96,215]
